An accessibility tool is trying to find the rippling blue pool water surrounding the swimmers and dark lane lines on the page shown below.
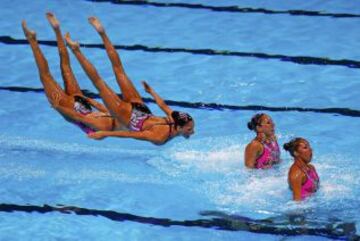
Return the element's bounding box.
[0,0,360,241]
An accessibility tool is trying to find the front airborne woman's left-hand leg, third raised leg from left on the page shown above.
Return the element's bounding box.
[65,33,132,126]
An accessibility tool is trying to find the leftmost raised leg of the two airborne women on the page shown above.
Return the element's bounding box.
[21,20,71,106]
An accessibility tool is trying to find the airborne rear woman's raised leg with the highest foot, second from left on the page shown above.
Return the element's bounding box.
[46,12,83,96]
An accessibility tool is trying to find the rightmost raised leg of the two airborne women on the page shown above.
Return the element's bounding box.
[88,17,143,103]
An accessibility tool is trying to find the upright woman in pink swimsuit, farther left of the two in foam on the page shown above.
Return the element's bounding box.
[245,113,280,169]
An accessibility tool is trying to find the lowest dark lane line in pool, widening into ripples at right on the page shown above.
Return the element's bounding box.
[0,204,360,240]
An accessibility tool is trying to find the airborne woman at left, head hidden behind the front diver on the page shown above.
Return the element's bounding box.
[22,12,118,137]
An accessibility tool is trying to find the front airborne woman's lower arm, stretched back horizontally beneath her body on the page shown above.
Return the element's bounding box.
[88,131,166,144]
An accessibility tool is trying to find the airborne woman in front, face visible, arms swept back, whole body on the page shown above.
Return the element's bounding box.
[65,17,195,145]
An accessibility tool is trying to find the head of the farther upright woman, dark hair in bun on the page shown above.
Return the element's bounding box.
[248,113,275,135]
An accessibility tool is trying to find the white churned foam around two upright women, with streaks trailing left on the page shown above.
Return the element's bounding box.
[0,135,360,220]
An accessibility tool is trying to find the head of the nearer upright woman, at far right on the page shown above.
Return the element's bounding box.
[284,137,312,162]
